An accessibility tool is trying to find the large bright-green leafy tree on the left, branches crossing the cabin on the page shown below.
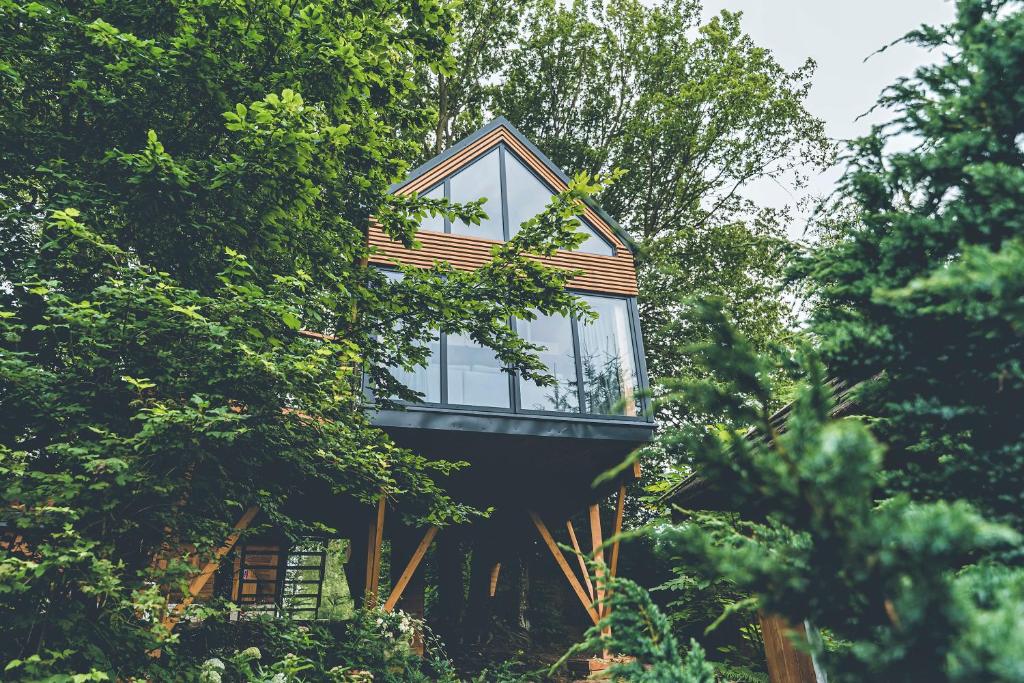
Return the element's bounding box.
[0,0,601,680]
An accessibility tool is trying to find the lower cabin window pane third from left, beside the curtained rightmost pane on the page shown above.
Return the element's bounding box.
[516,315,580,413]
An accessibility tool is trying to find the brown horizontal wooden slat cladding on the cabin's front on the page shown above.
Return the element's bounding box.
[369,126,637,296]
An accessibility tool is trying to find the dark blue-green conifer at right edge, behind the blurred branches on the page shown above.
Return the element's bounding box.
[800,0,1024,530]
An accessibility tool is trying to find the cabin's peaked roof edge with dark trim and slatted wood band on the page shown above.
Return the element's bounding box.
[390,117,637,258]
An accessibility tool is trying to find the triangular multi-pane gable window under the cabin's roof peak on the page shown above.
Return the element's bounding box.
[421,145,615,256]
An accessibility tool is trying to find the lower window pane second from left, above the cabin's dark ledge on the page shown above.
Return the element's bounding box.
[447,335,511,408]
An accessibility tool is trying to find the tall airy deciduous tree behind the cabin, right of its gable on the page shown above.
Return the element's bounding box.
[494,0,831,411]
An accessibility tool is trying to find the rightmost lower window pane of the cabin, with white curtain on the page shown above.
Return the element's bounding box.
[580,296,639,415]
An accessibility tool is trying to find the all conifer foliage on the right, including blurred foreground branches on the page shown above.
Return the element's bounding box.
[610,0,1024,682]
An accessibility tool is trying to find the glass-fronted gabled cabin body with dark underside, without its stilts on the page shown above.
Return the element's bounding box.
[370,118,653,518]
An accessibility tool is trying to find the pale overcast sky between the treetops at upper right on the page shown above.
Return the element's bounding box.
[703,0,954,238]
